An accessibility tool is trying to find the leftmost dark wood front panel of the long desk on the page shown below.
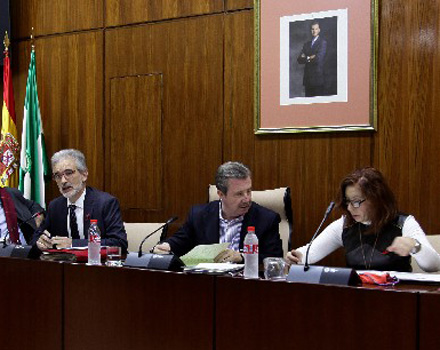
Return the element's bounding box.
[0,258,63,350]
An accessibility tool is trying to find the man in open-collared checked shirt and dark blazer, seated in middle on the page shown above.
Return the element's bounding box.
[153,162,283,263]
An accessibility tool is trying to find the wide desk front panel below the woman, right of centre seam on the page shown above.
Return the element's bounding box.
[216,278,417,350]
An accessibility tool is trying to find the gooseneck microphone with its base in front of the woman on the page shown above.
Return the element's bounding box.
[287,202,360,286]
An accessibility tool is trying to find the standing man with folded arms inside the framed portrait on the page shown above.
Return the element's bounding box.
[297,22,327,97]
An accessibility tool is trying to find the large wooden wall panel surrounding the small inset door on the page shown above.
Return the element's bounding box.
[105,16,223,222]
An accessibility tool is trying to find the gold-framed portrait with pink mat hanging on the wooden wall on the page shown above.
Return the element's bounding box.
[254,0,378,134]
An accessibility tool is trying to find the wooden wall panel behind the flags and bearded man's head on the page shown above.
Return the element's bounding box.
[14,32,104,199]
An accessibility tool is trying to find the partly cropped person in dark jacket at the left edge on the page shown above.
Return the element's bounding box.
[0,187,44,245]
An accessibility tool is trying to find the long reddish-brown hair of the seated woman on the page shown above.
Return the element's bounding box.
[337,167,398,233]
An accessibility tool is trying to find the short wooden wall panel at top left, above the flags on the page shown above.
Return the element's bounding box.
[10,0,104,38]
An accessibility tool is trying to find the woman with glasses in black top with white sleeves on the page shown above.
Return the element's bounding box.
[286,167,440,272]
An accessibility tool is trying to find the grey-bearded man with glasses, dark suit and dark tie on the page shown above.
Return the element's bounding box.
[33,149,128,251]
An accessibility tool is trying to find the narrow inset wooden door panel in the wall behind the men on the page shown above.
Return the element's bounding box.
[107,74,163,210]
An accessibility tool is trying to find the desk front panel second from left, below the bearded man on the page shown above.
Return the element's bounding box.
[64,265,214,350]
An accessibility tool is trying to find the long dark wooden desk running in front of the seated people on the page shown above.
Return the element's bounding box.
[0,258,440,350]
